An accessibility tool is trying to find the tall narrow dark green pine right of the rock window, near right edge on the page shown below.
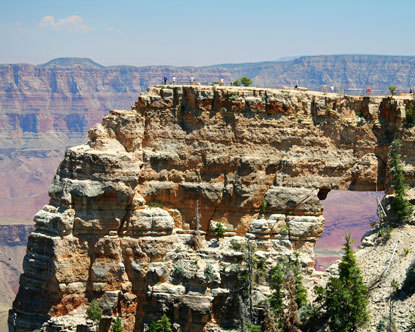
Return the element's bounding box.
[389,140,413,223]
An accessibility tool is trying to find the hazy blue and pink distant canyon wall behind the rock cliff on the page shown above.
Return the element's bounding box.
[0,55,415,220]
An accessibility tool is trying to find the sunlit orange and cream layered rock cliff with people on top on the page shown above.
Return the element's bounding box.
[9,86,415,332]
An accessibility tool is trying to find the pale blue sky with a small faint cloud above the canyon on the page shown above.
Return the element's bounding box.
[0,0,415,66]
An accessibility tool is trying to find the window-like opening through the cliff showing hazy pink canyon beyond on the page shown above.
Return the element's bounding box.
[314,190,384,271]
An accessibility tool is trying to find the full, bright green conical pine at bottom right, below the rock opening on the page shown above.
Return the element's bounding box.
[325,234,369,332]
